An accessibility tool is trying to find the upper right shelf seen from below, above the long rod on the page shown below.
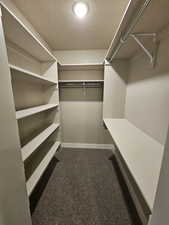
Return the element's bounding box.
[106,0,169,60]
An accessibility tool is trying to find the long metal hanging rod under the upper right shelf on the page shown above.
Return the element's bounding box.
[107,0,152,62]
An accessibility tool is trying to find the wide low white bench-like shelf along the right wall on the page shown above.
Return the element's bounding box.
[104,119,164,210]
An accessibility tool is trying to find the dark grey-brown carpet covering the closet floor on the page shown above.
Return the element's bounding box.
[31,149,140,225]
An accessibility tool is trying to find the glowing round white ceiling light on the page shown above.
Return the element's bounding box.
[73,2,89,19]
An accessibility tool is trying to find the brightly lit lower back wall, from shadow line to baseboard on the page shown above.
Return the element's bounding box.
[61,101,111,144]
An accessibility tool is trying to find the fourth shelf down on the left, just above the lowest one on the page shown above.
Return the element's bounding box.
[21,124,59,161]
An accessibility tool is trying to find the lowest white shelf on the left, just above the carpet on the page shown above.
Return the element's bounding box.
[26,142,60,196]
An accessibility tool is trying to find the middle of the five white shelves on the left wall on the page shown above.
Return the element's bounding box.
[16,104,58,120]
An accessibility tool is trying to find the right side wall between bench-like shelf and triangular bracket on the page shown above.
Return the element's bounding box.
[125,38,169,145]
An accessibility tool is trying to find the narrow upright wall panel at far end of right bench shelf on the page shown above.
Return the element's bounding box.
[103,60,128,118]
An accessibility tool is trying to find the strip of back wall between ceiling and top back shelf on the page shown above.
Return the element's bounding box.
[54,49,107,64]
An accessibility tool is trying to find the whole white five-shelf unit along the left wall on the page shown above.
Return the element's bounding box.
[2,1,60,205]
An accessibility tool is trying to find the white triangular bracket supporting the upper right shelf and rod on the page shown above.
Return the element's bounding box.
[130,33,159,68]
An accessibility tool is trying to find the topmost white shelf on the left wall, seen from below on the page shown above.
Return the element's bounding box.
[2,8,56,62]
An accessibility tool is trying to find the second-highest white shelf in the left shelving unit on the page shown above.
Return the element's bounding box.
[9,64,57,85]
